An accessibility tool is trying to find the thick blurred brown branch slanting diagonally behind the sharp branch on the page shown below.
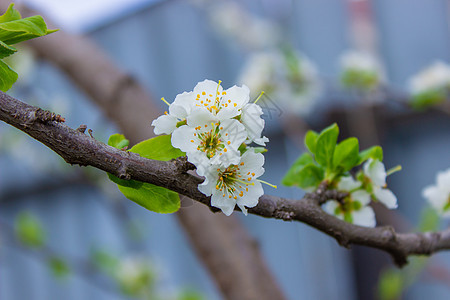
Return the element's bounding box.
[0,0,285,300]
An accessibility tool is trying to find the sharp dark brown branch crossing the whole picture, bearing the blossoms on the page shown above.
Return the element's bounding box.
[0,93,450,266]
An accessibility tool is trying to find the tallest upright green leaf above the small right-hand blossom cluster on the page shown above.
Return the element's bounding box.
[315,123,339,170]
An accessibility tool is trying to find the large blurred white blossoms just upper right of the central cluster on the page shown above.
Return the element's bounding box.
[238,51,321,115]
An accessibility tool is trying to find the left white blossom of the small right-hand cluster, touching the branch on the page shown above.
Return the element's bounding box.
[322,176,376,227]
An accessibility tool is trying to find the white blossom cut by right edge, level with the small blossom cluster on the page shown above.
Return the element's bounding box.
[422,169,450,217]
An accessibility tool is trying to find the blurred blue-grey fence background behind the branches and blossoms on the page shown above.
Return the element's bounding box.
[0,0,450,300]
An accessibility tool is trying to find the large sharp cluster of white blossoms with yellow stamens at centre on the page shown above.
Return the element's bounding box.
[152,80,269,215]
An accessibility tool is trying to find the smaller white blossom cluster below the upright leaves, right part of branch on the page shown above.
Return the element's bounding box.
[322,159,397,227]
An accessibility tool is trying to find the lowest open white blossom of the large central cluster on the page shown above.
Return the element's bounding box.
[198,149,264,216]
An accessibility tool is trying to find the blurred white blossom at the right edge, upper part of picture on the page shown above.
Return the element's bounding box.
[409,61,450,95]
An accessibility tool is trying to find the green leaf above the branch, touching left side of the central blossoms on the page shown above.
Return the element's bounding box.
[130,135,185,161]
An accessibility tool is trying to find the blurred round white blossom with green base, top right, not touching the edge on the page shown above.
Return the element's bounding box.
[340,50,385,90]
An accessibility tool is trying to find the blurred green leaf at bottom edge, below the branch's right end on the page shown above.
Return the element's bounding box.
[378,269,404,300]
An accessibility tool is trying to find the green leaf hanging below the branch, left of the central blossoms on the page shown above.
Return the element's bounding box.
[118,183,180,214]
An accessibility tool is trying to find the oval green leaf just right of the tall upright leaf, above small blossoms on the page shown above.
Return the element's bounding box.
[333,137,359,172]
